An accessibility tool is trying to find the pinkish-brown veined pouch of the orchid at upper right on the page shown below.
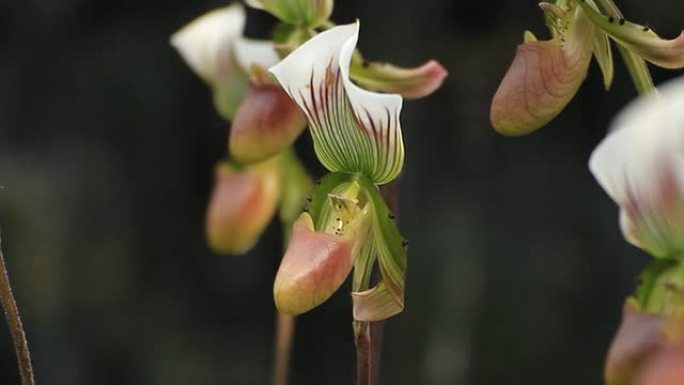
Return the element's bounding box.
[490,3,596,135]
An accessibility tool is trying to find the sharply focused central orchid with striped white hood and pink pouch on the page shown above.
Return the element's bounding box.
[269,22,446,321]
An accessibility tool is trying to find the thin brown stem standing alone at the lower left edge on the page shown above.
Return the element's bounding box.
[0,231,35,385]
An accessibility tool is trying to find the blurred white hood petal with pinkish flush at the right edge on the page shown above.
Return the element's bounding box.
[589,78,684,256]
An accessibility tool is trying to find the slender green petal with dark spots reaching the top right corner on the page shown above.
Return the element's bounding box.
[579,1,684,68]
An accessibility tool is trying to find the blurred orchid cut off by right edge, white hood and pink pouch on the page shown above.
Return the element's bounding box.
[589,78,684,385]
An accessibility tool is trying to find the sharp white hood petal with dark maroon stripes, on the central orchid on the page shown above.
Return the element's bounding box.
[269,22,404,184]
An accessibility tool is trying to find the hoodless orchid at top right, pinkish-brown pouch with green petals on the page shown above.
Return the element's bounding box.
[490,0,684,135]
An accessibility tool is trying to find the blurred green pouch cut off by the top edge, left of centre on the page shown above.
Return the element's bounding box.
[247,0,333,28]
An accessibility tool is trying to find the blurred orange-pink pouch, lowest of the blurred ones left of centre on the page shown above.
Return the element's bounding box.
[206,157,280,255]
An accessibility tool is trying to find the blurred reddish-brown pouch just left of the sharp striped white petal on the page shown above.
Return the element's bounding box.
[229,67,306,163]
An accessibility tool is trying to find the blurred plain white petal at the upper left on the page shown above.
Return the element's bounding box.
[171,3,245,86]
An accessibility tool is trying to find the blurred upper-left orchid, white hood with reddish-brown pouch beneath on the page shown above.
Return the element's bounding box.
[171,3,306,163]
